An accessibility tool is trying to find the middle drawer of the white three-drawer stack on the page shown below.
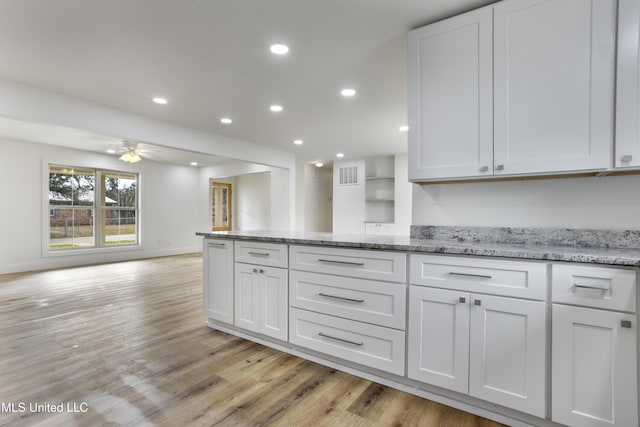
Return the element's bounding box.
[289,270,407,330]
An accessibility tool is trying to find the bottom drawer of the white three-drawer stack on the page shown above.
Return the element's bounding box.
[289,308,404,375]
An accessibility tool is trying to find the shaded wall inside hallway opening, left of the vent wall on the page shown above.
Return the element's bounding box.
[303,164,333,232]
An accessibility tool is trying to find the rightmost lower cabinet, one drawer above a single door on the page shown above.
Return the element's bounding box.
[551,265,638,427]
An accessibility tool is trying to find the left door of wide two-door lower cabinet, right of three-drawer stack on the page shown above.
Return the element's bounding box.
[407,286,469,394]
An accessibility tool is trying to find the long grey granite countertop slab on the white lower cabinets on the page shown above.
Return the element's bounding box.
[196,231,640,267]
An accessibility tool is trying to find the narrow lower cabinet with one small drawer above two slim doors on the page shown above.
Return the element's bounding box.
[235,242,288,341]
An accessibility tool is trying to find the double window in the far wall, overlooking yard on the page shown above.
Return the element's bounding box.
[48,165,139,251]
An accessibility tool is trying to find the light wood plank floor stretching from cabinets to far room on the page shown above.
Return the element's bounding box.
[0,255,499,427]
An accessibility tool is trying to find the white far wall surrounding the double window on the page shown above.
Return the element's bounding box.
[0,139,207,273]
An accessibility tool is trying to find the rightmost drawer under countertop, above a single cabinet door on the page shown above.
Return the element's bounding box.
[551,264,636,312]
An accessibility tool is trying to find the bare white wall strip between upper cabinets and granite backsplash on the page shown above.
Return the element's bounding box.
[412,175,640,230]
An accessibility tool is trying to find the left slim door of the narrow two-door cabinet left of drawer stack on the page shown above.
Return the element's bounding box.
[235,262,260,332]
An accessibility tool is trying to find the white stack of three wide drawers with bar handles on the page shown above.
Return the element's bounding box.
[289,246,407,375]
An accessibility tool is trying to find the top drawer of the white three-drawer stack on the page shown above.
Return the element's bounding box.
[289,246,407,283]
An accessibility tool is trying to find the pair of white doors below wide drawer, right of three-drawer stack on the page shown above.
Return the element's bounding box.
[408,286,546,418]
